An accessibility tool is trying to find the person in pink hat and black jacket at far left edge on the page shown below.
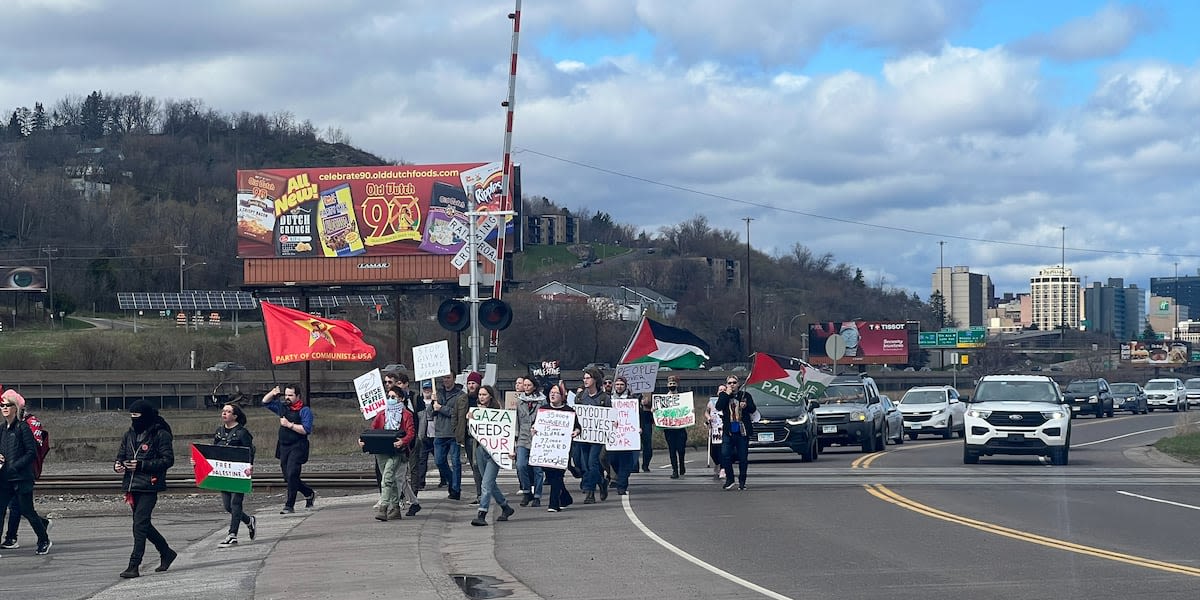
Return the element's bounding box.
[0,390,53,554]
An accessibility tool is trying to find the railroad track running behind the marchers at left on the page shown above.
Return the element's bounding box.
[36,470,377,494]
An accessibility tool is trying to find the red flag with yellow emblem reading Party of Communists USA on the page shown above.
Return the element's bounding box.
[259,302,374,365]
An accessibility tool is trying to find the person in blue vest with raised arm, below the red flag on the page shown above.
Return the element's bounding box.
[263,385,317,515]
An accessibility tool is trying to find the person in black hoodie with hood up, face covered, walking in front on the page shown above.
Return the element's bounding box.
[113,400,179,578]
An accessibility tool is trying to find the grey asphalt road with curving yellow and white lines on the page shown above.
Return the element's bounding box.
[496,413,1200,600]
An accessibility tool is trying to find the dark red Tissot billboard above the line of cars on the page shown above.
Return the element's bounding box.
[809,320,908,365]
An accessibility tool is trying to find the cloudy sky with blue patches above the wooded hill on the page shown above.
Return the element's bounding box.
[0,0,1200,298]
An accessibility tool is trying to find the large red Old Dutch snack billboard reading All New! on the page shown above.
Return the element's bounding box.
[236,162,518,260]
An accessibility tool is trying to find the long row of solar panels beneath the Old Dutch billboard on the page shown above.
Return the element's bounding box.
[116,289,389,311]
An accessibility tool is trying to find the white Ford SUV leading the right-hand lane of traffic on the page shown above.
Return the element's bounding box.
[962,376,1070,464]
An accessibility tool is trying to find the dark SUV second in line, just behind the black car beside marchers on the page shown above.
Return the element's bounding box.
[812,376,887,452]
